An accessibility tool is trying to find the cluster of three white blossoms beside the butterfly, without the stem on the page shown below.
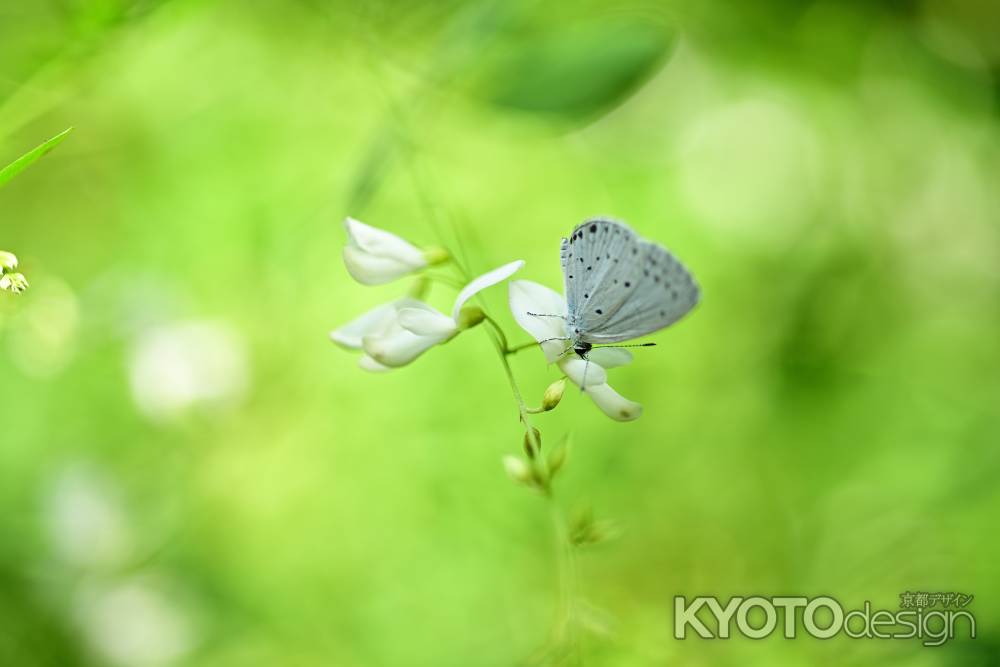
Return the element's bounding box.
[330,218,642,421]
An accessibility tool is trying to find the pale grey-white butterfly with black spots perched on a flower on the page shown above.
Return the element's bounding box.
[560,218,701,358]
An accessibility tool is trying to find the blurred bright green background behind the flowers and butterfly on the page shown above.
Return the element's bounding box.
[0,0,1000,667]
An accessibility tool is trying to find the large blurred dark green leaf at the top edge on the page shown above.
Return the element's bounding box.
[474,21,673,121]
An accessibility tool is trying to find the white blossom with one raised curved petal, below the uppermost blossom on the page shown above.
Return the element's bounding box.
[330,260,524,371]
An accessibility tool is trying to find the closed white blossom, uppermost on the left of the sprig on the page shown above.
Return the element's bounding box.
[344,218,447,285]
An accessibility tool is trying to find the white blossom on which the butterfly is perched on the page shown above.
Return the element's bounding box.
[510,280,642,421]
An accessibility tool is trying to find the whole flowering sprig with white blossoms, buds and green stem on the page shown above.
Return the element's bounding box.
[330,218,642,656]
